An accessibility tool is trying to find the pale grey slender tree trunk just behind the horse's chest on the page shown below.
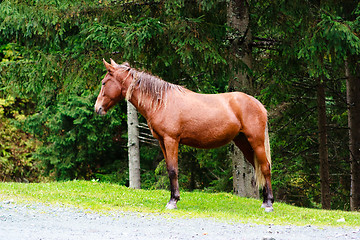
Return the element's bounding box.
[127,101,140,189]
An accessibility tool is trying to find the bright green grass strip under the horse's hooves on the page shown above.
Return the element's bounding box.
[0,181,360,227]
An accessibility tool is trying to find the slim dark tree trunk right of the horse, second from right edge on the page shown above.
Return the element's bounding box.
[317,78,331,209]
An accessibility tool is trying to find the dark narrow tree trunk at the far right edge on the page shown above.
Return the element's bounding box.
[345,57,360,211]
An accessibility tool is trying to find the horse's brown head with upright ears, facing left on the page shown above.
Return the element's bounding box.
[95,59,130,115]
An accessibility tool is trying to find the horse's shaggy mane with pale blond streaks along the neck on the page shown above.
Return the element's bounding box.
[120,63,185,109]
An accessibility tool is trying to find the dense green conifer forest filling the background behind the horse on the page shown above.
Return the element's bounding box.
[0,0,360,210]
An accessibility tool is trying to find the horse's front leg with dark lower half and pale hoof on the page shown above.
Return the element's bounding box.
[160,138,180,209]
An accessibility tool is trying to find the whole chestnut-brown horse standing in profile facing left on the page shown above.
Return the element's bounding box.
[95,59,274,211]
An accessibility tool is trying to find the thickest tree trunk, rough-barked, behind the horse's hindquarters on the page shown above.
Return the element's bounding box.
[227,0,259,198]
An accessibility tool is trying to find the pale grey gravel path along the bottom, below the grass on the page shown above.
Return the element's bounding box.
[0,201,360,240]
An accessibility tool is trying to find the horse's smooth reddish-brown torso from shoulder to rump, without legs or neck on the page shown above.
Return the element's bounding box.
[149,91,265,148]
